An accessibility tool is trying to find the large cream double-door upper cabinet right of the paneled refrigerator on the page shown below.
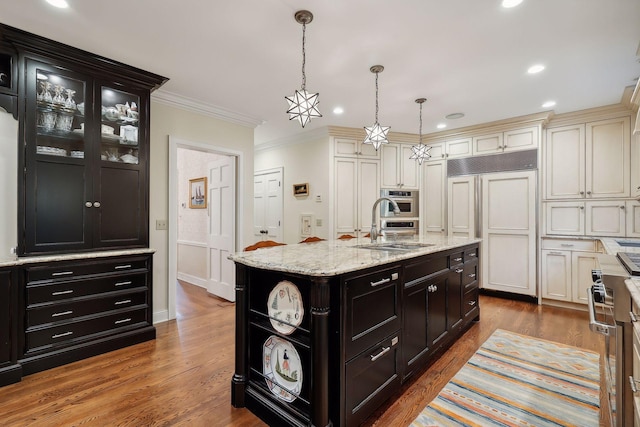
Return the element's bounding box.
[544,117,631,200]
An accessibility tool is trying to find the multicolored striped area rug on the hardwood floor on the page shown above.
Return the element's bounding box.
[411,329,600,427]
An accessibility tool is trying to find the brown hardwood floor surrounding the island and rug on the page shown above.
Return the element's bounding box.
[0,283,605,427]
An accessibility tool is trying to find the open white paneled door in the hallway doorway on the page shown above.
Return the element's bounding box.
[207,156,236,301]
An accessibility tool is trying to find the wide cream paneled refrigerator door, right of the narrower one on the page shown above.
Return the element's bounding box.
[481,171,536,296]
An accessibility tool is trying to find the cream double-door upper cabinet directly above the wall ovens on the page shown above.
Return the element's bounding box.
[381,144,419,190]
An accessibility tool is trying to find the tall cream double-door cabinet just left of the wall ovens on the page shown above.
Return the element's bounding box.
[334,157,380,237]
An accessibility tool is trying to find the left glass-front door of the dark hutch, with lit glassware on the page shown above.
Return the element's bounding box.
[24,61,93,253]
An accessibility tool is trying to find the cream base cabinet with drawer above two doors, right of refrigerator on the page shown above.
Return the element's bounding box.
[540,239,599,304]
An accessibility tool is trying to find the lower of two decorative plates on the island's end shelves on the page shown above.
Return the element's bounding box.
[262,335,302,402]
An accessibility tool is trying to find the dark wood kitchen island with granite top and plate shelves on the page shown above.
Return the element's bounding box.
[230,237,480,426]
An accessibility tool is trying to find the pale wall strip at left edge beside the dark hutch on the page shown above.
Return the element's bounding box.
[0,108,18,259]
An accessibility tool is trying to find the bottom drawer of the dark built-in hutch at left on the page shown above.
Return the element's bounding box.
[25,308,147,351]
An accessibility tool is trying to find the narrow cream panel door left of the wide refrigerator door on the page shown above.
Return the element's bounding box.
[447,176,476,238]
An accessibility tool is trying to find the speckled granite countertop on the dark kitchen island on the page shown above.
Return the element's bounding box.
[229,236,480,276]
